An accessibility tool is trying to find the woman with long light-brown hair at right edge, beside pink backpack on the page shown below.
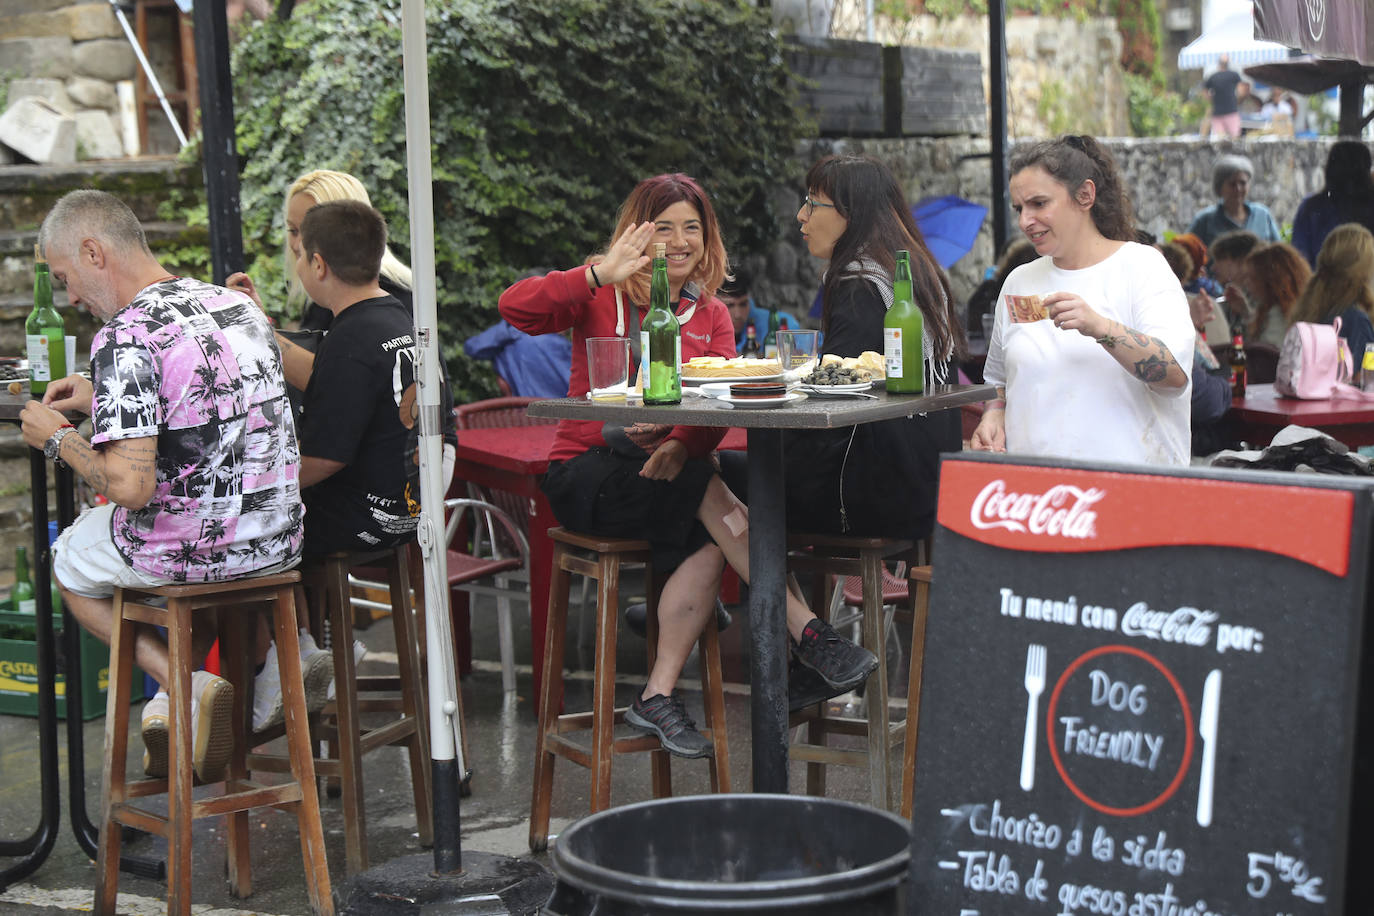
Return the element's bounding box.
[1293,222,1374,364]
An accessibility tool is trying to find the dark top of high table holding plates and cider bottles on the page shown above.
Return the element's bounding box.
[528,385,998,430]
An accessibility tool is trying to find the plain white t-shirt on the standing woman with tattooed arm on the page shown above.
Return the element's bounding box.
[984,242,1194,466]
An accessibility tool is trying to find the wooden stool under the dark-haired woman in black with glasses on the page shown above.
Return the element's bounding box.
[787,534,915,809]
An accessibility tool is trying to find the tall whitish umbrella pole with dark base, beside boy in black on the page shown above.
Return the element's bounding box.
[401,0,463,875]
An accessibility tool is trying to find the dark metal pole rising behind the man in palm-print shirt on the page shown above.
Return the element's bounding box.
[194,0,243,283]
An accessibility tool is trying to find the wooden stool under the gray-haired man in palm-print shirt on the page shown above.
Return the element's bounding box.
[95,571,334,916]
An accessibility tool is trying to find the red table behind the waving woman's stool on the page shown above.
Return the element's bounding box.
[453,423,746,696]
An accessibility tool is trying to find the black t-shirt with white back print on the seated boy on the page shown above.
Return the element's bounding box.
[301,295,439,556]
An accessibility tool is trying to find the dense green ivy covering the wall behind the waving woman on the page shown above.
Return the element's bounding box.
[234,0,808,400]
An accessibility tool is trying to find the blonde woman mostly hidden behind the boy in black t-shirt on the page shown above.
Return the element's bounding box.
[224,169,414,333]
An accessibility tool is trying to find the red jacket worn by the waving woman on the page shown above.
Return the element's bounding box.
[497,266,735,461]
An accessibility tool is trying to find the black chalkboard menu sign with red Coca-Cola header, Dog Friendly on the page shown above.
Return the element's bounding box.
[910,456,1374,916]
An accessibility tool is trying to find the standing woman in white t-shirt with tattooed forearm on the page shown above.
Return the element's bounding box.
[971,136,1194,464]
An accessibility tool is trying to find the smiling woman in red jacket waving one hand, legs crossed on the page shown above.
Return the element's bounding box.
[499,173,878,757]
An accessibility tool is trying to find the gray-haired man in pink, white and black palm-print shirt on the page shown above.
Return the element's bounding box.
[21,191,304,781]
